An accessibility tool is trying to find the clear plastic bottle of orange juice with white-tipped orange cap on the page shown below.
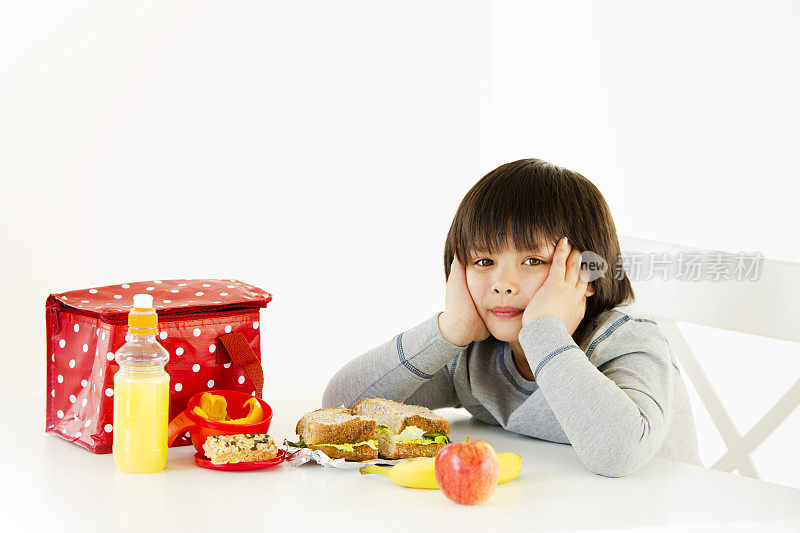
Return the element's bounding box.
[112,294,169,474]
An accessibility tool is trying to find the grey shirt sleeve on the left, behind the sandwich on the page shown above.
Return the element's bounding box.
[322,313,465,409]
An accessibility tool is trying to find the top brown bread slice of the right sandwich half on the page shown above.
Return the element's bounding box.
[353,398,450,434]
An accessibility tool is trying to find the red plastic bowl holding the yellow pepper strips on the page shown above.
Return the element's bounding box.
[167,390,272,453]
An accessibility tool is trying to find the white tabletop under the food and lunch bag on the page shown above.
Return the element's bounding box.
[9,392,800,533]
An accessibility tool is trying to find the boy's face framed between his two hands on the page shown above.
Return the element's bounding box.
[466,236,555,342]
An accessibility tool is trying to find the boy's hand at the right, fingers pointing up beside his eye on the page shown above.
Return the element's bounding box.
[522,237,594,335]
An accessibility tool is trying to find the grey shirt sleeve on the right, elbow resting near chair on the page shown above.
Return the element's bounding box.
[514,315,675,477]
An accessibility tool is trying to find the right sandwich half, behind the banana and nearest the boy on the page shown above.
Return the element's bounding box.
[352,398,450,459]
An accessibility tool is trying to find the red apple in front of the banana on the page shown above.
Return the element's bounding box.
[434,437,500,505]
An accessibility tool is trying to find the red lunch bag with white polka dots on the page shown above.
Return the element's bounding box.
[45,279,272,453]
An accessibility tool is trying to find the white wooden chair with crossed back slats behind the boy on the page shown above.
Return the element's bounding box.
[620,236,800,478]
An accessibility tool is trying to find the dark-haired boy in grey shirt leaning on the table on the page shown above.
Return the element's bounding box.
[322,159,702,477]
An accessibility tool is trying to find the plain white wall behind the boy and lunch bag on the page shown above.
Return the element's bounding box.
[0,0,800,487]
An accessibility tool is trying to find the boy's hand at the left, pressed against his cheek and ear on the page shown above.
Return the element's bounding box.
[439,257,489,346]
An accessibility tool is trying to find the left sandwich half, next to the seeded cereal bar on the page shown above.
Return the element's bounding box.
[295,407,378,461]
